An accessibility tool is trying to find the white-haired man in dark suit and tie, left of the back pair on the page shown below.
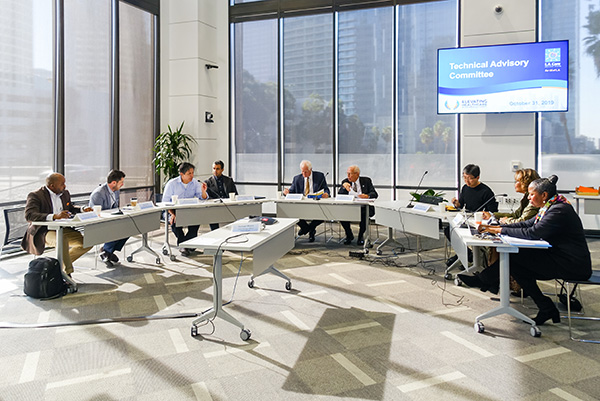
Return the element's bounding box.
[283,160,329,242]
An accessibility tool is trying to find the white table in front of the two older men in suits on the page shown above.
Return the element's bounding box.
[273,198,373,247]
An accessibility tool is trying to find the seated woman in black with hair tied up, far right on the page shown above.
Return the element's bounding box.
[458,175,592,325]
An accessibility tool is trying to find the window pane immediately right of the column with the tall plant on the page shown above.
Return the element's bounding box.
[234,20,277,182]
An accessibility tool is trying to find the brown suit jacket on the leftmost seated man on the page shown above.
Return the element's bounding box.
[21,187,80,255]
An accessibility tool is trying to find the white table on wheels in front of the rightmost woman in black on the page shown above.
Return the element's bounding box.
[449,220,549,337]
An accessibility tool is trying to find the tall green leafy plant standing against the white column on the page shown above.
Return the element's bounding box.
[153,121,196,187]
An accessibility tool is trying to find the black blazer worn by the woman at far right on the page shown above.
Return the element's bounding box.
[502,203,592,280]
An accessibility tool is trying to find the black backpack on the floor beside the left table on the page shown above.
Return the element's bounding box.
[23,257,69,299]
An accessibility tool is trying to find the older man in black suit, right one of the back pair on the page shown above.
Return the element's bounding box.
[338,165,379,245]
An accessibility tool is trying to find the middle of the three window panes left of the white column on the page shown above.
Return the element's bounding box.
[64,0,111,193]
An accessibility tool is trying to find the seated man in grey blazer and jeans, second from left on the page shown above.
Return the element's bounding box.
[90,170,129,267]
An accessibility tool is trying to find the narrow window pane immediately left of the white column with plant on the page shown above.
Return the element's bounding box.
[119,2,154,187]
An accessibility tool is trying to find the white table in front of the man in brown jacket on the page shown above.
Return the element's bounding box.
[32,208,162,292]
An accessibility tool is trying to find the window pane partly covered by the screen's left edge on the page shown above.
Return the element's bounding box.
[397,1,457,187]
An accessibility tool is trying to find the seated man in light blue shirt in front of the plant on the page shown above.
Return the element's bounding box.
[163,162,208,256]
